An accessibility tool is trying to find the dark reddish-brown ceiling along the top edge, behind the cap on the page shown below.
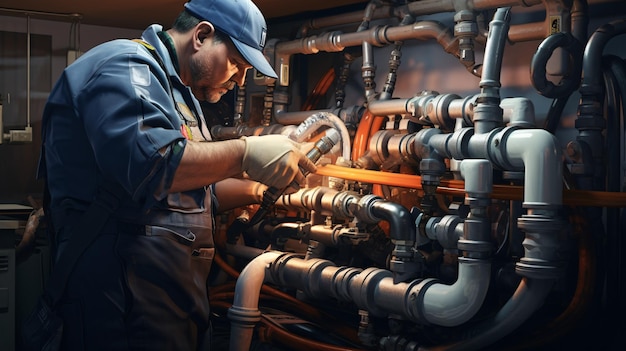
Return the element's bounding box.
[0,0,365,29]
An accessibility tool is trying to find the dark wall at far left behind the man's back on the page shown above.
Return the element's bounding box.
[0,16,141,205]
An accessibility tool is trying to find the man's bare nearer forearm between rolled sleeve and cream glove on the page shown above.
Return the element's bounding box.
[170,139,245,193]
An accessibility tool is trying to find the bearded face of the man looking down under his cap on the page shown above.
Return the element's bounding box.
[189,32,252,103]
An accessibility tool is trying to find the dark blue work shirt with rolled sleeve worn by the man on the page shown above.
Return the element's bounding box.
[39,25,211,227]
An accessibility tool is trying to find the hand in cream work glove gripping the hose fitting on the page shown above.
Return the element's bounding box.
[241,134,316,191]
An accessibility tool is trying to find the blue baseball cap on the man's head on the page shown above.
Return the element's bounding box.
[185,0,278,78]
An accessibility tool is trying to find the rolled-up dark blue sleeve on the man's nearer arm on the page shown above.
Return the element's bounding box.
[75,47,186,208]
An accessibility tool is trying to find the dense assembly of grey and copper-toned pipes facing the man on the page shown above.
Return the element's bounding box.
[202,0,626,350]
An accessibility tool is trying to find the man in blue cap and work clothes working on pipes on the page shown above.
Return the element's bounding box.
[33,0,315,350]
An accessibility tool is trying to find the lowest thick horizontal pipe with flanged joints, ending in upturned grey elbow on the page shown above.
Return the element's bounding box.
[269,249,490,325]
